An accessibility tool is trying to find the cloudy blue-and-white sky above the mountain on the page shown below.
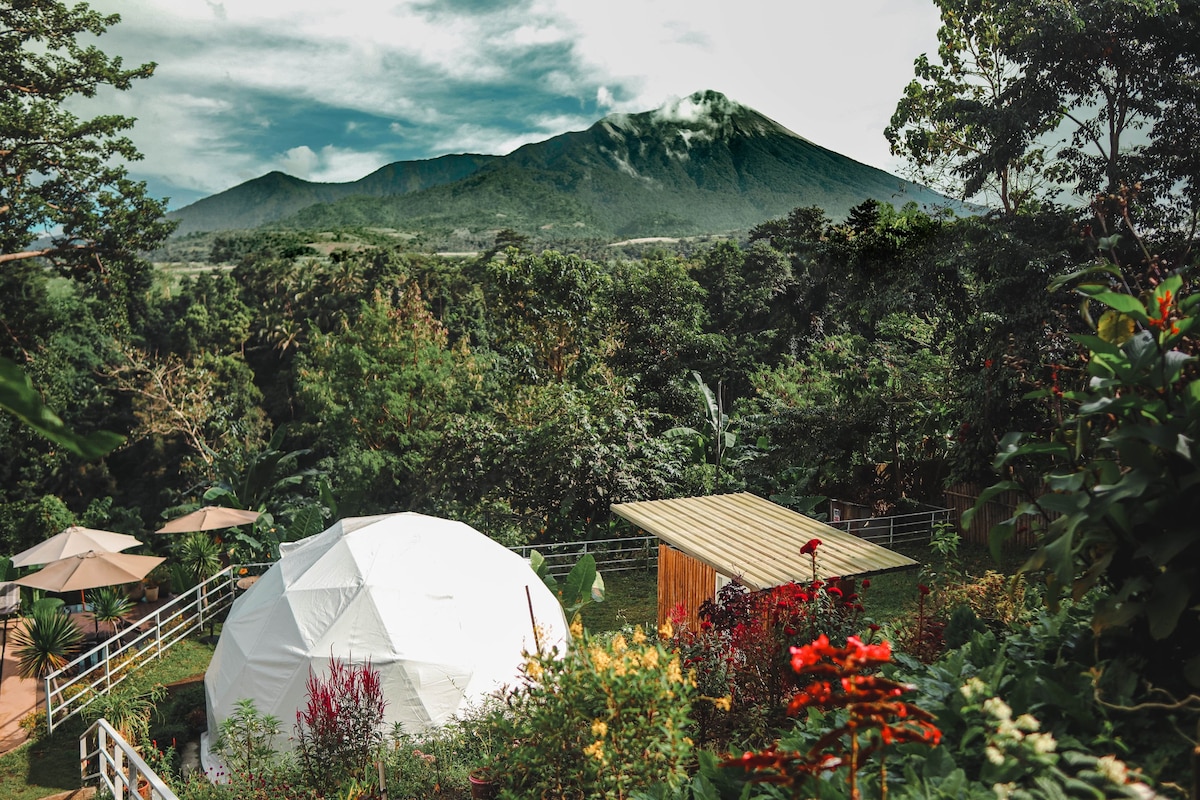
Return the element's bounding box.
[90,0,938,207]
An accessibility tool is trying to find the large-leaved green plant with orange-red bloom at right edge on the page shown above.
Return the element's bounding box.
[965,266,1200,688]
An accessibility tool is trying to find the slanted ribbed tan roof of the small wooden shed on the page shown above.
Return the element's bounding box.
[612,492,917,589]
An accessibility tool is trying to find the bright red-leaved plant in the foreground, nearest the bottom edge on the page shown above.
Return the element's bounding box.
[725,634,942,800]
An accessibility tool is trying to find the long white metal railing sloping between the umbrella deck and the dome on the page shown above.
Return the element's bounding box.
[46,565,262,732]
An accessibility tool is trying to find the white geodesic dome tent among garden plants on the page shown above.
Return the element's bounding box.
[204,513,566,766]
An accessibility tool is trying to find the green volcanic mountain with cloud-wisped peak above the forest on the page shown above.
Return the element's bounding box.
[170,91,956,237]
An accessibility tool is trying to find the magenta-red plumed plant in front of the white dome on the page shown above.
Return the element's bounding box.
[296,656,388,793]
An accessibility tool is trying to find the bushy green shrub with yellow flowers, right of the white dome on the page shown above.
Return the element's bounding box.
[491,628,694,800]
